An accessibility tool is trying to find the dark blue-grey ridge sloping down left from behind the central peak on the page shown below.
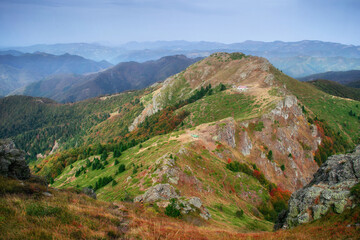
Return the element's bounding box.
[20,55,199,102]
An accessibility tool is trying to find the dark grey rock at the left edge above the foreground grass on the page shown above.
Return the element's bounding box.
[0,139,30,180]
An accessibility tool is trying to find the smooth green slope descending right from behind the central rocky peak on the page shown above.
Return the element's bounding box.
[272,65,360,144]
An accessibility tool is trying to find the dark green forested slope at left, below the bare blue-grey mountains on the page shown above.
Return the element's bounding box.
[0,90,148,159]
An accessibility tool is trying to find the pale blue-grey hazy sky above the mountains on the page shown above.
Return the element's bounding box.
[0,0,360,47]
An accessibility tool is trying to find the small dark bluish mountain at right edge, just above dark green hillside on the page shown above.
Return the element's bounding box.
[299,70,360,87]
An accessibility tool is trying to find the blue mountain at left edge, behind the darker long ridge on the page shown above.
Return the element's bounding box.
[0,52,111,95]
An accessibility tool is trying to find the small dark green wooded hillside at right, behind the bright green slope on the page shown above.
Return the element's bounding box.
[308,79,360,101]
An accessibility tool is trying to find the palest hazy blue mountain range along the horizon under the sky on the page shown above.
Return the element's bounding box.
[3,40,360,77]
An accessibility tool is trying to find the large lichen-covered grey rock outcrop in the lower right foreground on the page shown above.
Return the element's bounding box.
[275,145,360,228]
